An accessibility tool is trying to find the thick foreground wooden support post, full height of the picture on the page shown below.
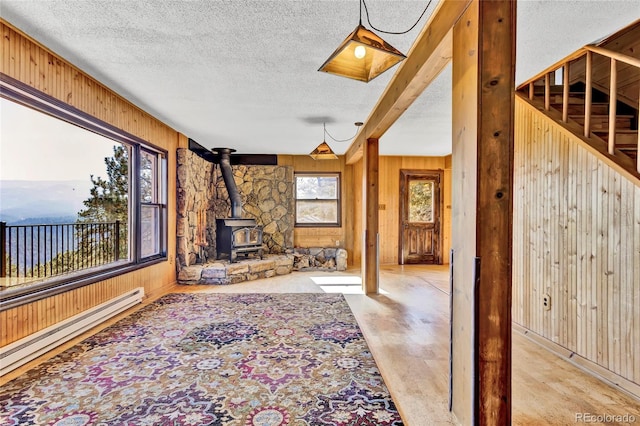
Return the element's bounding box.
[452,0,516,425]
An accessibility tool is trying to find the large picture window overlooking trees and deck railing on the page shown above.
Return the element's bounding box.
[0,76,167,301]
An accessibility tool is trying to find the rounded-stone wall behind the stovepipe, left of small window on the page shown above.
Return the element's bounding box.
[214,165,295,254]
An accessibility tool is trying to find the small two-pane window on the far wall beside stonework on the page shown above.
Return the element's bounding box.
[295,173,341,227]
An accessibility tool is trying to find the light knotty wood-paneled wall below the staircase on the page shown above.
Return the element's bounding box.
[513,98,640,384]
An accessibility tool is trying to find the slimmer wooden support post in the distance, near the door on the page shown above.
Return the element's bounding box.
[362,138,379,294]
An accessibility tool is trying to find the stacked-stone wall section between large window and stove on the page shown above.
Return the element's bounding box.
[176,148,216,271]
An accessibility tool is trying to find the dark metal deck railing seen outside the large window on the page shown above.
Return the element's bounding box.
[0,221,122,279]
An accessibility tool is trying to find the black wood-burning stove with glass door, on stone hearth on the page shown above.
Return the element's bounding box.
[216,218,262,262]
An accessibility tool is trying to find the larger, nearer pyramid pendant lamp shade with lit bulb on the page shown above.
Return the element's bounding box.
[318,25,406,82]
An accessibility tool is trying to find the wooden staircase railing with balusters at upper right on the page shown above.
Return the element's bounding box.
[518,46,640,173]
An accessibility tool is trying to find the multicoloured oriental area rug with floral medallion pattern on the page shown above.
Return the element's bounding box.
[0,293,403,426]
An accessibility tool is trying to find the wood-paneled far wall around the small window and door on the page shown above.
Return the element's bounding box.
[278,153,451,267]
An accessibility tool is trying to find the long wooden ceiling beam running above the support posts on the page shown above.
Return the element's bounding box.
[345,0,471,164]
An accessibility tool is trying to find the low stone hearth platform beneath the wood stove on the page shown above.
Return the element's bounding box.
[178,254,293,285]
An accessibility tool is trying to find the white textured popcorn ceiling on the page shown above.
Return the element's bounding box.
[0,0,640,155]
